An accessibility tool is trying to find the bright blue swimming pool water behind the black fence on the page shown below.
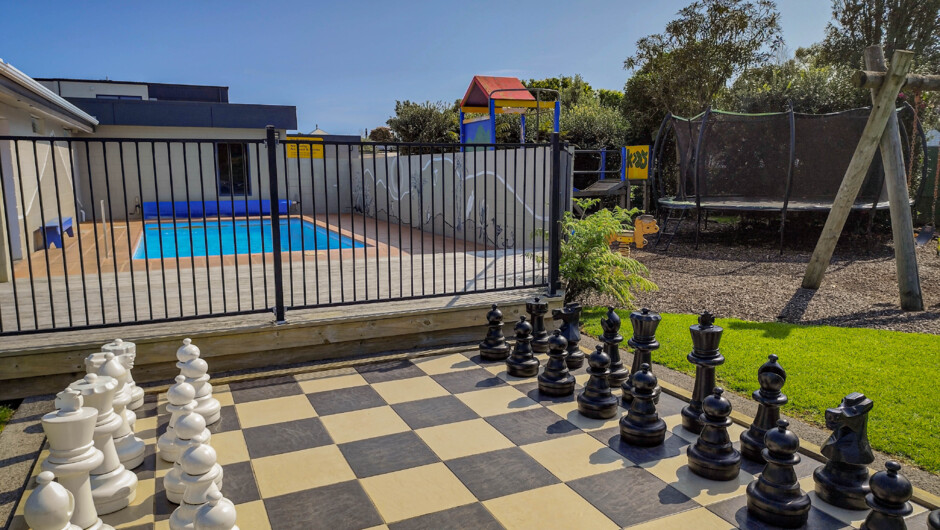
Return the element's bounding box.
[134,219,364,259]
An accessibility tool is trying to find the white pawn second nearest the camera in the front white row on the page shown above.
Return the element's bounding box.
[170,434,222,530]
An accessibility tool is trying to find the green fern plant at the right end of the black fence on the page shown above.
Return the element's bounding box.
[540,199,658,308]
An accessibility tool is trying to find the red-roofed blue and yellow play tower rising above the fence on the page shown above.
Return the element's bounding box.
[460,75,561,144]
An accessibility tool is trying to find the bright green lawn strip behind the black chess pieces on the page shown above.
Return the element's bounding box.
[582,307,940,473]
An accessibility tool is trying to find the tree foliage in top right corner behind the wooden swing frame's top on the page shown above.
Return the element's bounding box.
[814,0,940,71]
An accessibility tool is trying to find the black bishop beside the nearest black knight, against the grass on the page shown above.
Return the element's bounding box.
[741,354,787,462]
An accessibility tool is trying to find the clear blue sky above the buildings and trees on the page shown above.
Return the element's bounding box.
[0,0,830,134]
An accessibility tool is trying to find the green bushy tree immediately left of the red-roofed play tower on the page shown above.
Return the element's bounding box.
[386,100,460,143]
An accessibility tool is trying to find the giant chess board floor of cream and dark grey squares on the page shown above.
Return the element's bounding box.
[12,349,927,530]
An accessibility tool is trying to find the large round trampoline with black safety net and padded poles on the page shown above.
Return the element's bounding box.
[651,105,926,251]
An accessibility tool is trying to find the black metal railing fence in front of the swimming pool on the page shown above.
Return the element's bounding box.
[0,127,573,335]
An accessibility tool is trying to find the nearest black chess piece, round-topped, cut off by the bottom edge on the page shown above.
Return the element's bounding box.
[862,460,914,530]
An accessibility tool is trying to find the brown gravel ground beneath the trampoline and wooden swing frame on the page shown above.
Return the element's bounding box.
[624,223,940,334]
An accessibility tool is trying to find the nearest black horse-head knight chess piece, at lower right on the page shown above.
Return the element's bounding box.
[813,392,875,510]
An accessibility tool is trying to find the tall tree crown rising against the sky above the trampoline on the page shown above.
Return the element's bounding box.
[624,0,783,114]
